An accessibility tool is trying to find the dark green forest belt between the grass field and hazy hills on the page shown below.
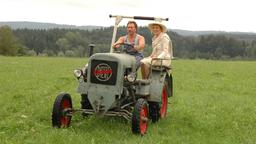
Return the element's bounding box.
[0,26,256,60]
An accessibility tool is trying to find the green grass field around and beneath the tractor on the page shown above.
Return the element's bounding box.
[0,56,256,144]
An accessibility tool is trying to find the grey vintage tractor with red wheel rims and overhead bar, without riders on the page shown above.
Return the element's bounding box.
[52,15,173,135]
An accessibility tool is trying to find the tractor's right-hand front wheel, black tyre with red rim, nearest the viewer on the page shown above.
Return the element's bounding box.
[132,98,149,135]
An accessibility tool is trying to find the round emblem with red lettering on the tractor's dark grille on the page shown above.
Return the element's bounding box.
[93,63,113,81]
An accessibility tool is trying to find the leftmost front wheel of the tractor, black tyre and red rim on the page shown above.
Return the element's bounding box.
[52,93,72,128]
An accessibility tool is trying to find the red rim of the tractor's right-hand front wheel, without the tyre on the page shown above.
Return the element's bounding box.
[140,106,148,134]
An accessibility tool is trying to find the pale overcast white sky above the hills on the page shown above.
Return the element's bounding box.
[0,0,256,32]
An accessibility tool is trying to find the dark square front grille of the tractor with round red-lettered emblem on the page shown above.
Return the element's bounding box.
[90,60,117,85]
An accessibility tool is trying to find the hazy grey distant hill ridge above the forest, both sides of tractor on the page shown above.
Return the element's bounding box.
[0,21,256,41]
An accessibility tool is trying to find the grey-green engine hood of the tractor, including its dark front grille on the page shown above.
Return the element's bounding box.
[86,53,136,114]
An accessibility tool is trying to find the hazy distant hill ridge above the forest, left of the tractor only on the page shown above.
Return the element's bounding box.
[0,21,101,30]
